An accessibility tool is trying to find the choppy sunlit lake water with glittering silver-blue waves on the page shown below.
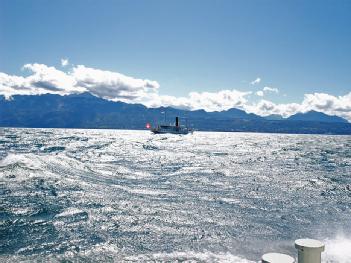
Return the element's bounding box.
[0,129,351,262]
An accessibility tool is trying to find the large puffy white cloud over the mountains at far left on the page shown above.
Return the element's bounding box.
[0,64,159,102]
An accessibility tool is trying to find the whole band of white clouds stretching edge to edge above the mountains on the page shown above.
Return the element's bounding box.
[0,64,351,121]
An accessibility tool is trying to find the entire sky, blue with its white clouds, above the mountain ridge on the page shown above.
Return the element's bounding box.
[0,0,351,121]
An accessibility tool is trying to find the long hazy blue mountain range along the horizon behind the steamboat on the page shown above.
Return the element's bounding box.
[0,93,351,134]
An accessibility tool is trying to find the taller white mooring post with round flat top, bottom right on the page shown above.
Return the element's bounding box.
[295,238,324,263]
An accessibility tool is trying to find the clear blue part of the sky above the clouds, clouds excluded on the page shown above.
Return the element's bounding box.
[0,0,351,119]
